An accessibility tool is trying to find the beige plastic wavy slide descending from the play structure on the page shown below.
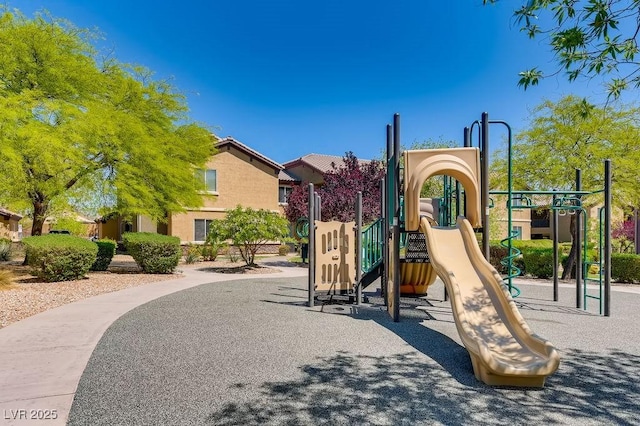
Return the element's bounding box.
[420,217,560,387]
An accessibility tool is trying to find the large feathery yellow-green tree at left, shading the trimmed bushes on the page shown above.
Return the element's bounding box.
[0,11,213,235]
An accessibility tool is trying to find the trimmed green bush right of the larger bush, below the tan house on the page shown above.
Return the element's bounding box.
[122,232,181,274]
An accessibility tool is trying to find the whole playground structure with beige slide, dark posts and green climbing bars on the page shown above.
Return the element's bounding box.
[309,113,611,387]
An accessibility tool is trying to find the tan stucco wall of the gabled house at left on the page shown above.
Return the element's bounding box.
[167,146,282,242]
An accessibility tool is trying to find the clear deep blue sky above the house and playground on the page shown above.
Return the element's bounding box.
[6,0,616,163]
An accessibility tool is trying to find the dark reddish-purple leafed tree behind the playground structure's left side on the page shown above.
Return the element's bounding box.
[284,152,384,223]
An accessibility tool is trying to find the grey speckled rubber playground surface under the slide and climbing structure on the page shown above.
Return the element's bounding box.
[58,276,640,425]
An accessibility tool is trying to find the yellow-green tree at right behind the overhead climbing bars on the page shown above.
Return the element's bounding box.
[492,96,640,279]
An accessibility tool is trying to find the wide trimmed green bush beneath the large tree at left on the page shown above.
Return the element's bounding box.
[22,234,98,282]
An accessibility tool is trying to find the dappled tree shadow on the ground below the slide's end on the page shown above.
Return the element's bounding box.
[206,349,640,425]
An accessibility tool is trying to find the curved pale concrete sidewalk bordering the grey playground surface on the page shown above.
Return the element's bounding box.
[0,267,307,425]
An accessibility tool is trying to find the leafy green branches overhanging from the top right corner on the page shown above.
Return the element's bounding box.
[483,0,640,98]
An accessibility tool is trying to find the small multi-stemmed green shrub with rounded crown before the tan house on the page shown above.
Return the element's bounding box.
[220,206,290,266]
